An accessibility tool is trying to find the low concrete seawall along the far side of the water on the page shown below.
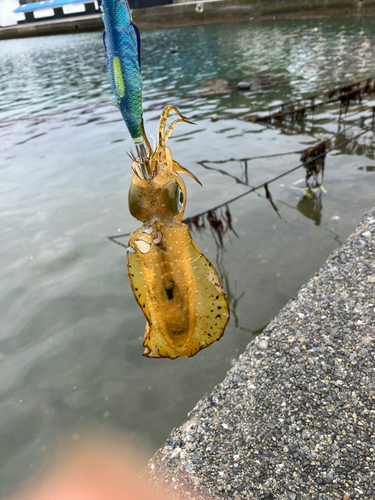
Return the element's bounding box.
[0,0,375,40]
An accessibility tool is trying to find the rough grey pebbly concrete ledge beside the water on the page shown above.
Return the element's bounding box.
[149,204,375,500]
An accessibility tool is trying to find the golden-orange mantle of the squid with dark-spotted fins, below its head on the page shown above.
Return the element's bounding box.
[127,219,229,359]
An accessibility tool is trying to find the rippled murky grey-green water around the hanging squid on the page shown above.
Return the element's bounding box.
[0,20,375,496]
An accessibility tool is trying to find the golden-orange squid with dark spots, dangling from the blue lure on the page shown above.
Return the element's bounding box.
[127,106,229,359]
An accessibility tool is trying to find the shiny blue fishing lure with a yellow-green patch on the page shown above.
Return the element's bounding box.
[102,0,147,152]
